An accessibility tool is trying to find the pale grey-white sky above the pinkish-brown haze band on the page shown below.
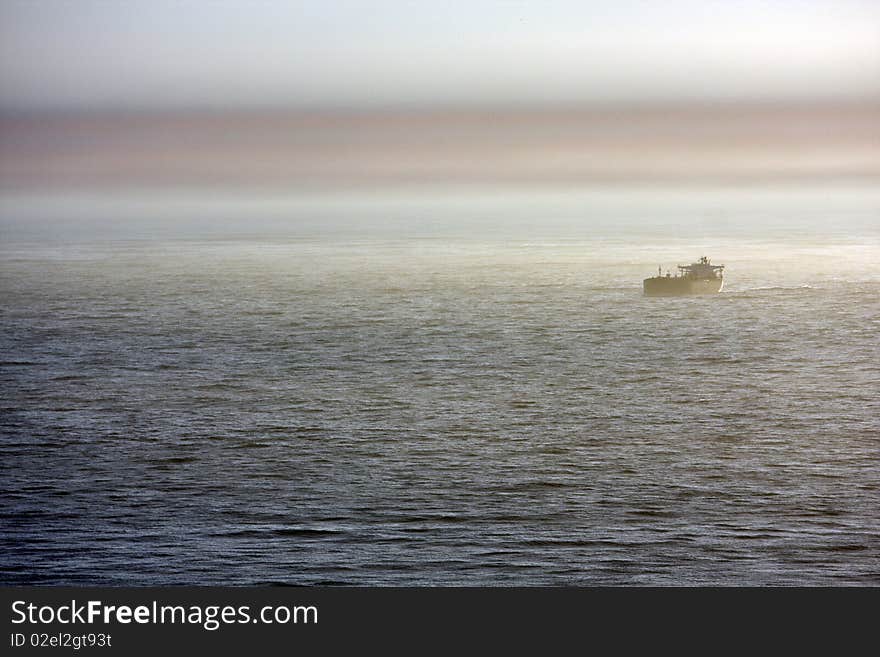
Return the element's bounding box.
[0,0,880,108]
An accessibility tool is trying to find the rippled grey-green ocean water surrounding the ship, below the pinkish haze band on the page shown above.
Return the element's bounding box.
[0,191,880,586]
